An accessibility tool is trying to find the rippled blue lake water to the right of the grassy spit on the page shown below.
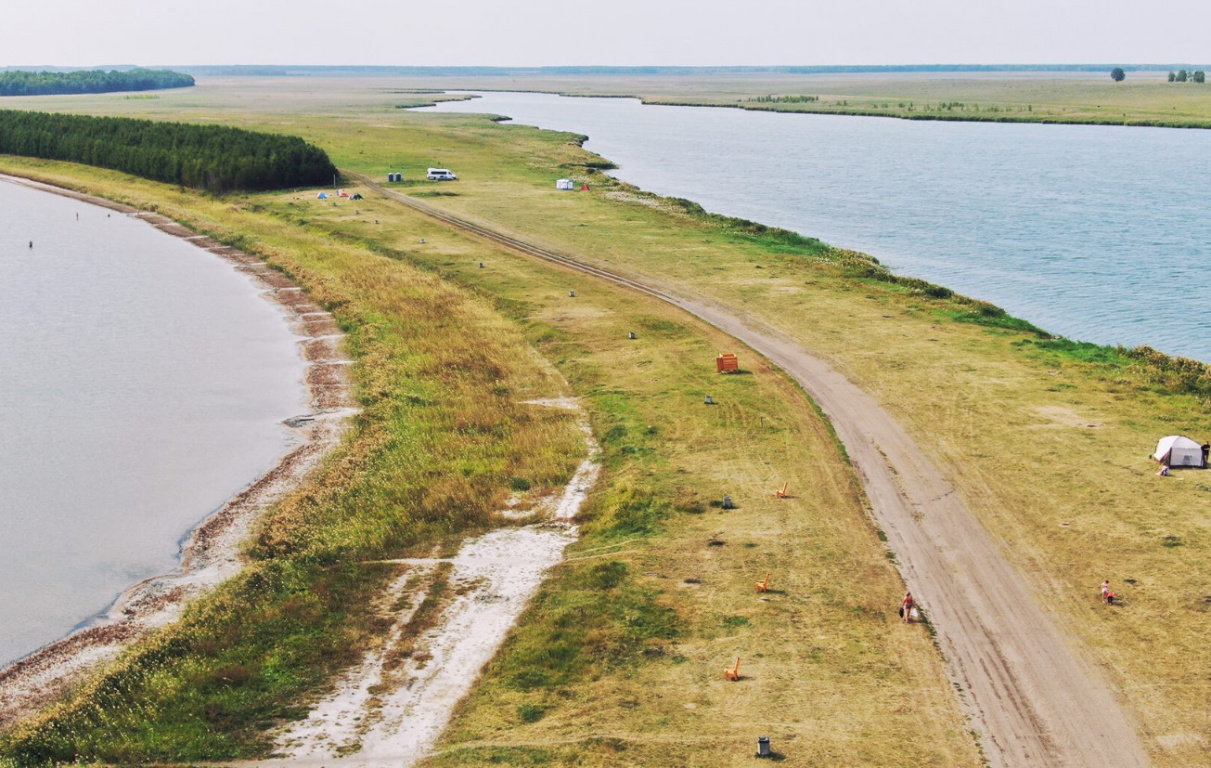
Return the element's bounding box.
[435,93,1211,361]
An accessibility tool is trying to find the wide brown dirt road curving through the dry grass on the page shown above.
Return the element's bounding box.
[363,179,1149,768]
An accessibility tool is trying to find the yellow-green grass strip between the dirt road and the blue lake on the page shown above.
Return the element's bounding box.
[288,96,1211,766]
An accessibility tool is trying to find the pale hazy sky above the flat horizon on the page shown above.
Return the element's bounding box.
[0,0,1211,67]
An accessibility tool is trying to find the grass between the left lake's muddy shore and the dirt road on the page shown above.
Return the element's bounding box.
[0,149,978,766]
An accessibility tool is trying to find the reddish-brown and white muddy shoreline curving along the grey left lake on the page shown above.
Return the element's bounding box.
[0,176,355,730]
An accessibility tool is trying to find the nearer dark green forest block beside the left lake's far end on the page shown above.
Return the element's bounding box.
[0,109,337,191]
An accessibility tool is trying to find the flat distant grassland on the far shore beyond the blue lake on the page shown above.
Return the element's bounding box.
[368,68,1211,128]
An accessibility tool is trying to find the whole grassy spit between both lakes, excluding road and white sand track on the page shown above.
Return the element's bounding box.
[0,80,1211,766]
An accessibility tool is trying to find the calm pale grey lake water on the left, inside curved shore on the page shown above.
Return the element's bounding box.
[0,182,305,666]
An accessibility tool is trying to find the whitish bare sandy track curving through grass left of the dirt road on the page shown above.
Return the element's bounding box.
[268,399,599,768]
